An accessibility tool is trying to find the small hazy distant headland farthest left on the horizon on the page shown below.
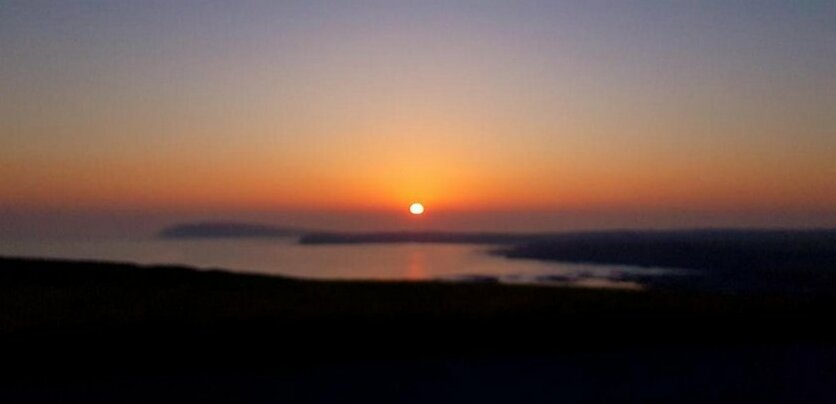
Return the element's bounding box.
[159,222,305,238]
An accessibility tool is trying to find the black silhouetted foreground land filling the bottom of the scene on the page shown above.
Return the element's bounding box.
[0,258,836,402]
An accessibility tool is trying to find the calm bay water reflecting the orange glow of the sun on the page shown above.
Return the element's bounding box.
[0,239,668,288]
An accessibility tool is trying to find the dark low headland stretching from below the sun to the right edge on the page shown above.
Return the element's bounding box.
[300,230,836,294]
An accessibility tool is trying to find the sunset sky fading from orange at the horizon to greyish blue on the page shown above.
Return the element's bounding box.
[0,0,836,233]
